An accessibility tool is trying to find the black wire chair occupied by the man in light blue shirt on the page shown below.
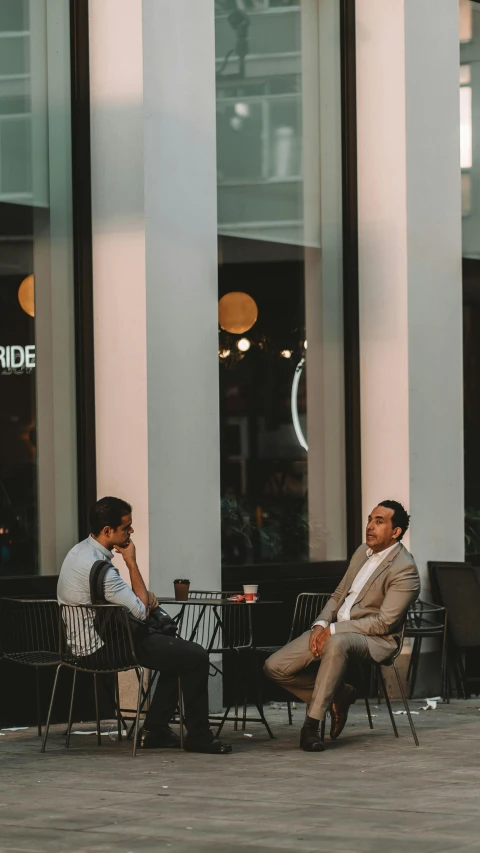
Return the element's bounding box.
[42,604,144,757]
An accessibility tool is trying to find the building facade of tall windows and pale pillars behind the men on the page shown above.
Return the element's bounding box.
[0,0,472,594]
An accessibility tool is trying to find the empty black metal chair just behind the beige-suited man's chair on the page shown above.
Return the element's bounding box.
[405,599,450,702]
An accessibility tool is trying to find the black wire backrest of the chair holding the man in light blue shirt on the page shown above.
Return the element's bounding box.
[60,604,141,672]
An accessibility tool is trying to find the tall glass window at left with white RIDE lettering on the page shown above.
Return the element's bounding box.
[0,0,77,575]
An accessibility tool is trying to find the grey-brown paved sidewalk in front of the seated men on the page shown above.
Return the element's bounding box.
[0,699,480,853]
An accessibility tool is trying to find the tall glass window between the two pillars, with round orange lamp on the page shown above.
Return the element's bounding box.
[215,0,346,564]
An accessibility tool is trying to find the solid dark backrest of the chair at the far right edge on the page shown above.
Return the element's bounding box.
[436,563,480,649]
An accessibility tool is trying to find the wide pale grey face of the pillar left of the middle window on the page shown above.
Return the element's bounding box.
[143,0,220,593]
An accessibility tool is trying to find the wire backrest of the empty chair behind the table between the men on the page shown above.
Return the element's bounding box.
[178,598,251,652]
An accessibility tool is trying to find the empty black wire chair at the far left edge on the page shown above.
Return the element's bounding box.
[0,598,60,737]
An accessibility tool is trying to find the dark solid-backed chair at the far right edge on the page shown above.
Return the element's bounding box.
[429,563,480,698]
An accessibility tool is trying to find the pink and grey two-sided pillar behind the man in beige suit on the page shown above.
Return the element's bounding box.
[357,0,464,577]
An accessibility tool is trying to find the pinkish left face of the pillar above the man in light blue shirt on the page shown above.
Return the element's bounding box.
[89,0,149,580]
